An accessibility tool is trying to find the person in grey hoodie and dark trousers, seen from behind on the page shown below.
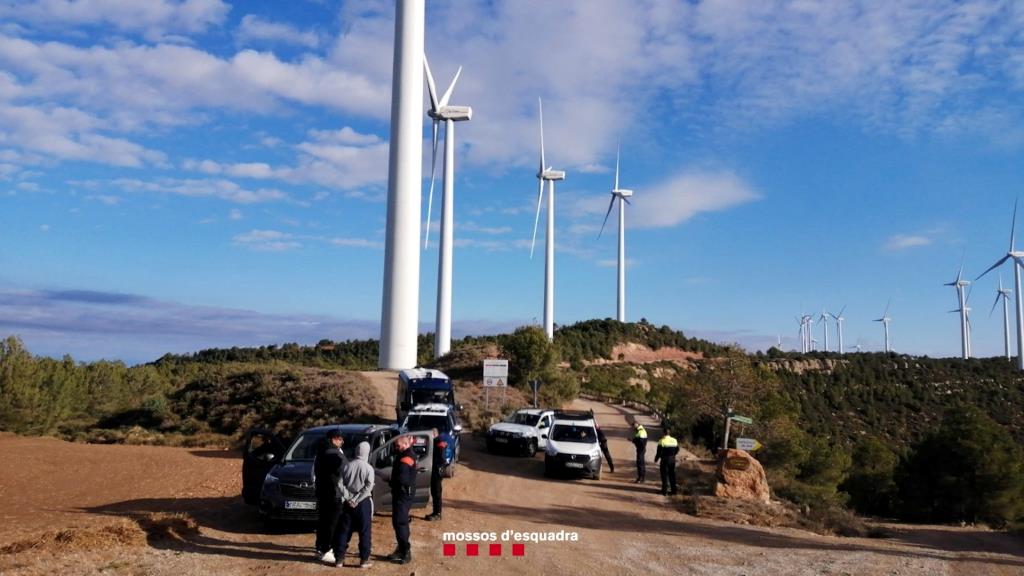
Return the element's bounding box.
[334,442,374,568]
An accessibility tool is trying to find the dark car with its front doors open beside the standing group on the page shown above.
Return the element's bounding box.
[242,424,432,521]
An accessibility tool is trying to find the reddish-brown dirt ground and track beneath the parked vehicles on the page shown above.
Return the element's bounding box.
[0,401,1024,576]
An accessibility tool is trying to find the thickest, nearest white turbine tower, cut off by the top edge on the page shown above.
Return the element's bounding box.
[377,0,426,370]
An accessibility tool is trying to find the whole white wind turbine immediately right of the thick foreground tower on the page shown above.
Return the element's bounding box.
[423,55,473,358]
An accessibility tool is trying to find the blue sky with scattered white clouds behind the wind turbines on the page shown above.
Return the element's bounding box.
[0,0,1024,363]
